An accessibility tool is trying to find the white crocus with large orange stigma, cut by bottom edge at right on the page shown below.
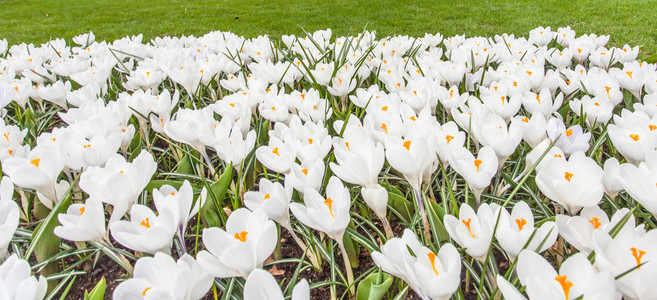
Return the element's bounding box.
[516,250,616,300]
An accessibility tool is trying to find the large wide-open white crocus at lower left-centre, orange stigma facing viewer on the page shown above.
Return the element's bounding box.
[197,208,278,279]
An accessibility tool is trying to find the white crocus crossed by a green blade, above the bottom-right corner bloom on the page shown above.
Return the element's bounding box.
[555,206,635,255]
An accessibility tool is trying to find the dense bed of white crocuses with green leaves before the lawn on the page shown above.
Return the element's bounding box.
[0,27,657,299]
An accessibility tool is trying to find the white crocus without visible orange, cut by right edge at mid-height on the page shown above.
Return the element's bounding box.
[618,150,657,215]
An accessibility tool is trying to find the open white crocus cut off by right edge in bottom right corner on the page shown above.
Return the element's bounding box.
[593,227,657,299]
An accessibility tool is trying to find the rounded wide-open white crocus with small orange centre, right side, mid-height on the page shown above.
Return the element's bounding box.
[536,151,604,215]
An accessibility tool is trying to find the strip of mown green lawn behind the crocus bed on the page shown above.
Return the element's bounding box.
[0,0,657,55]
